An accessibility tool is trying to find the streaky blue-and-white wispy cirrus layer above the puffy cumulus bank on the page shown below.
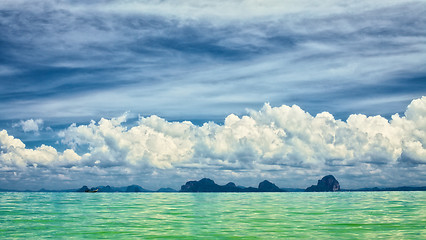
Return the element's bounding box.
[0,1,426,124]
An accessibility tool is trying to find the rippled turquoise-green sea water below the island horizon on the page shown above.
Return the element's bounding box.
[0,192,426,239]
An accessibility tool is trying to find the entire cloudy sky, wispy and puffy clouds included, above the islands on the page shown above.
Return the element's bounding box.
[0,0,426,190]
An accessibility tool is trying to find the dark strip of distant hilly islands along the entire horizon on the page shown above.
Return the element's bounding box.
[0,175,426,193]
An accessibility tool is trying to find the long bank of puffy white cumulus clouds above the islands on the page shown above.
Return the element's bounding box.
[0,97,426,187]
